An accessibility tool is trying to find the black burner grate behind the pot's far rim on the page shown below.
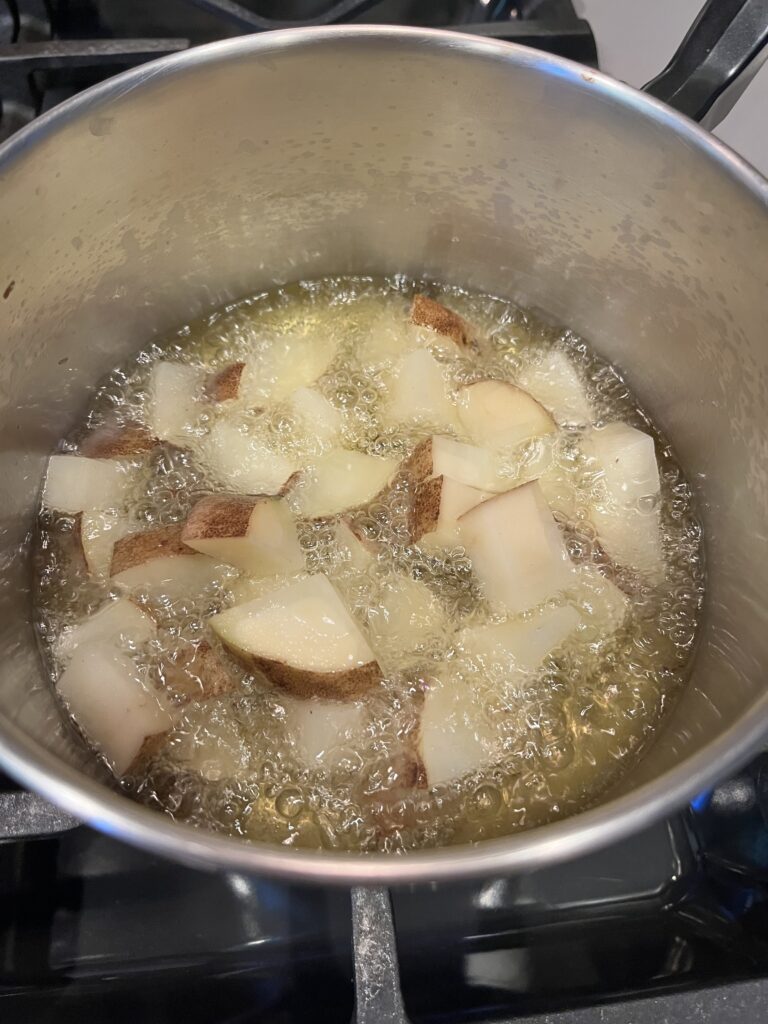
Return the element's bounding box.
[0,0,597,141]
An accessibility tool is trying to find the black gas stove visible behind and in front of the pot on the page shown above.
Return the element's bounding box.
[0,0,768,1024]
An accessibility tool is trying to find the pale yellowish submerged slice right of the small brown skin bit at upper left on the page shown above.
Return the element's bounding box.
[240,334,336,407]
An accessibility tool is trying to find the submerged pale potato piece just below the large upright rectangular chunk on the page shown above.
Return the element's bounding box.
[458,605,582,672]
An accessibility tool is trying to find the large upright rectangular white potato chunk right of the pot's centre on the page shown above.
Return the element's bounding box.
[459,480,573,614]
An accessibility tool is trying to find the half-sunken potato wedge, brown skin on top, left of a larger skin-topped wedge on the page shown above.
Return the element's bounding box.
[111,524,221,597]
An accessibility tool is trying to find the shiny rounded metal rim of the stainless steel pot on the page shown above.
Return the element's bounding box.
[0,26,768,886]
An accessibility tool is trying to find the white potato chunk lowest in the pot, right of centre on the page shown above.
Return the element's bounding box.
[417,679,502,788]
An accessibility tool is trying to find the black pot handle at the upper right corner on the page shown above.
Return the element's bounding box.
[643,0,768,128]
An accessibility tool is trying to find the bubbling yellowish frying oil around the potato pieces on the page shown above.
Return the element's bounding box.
[37,278,703,851]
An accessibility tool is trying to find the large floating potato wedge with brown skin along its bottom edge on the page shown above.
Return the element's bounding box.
[210,575,381,699]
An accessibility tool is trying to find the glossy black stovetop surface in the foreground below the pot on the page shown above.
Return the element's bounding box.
[0,756,768,1024]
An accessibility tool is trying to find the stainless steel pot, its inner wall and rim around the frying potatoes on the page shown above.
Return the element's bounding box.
[0,6,768,884]
